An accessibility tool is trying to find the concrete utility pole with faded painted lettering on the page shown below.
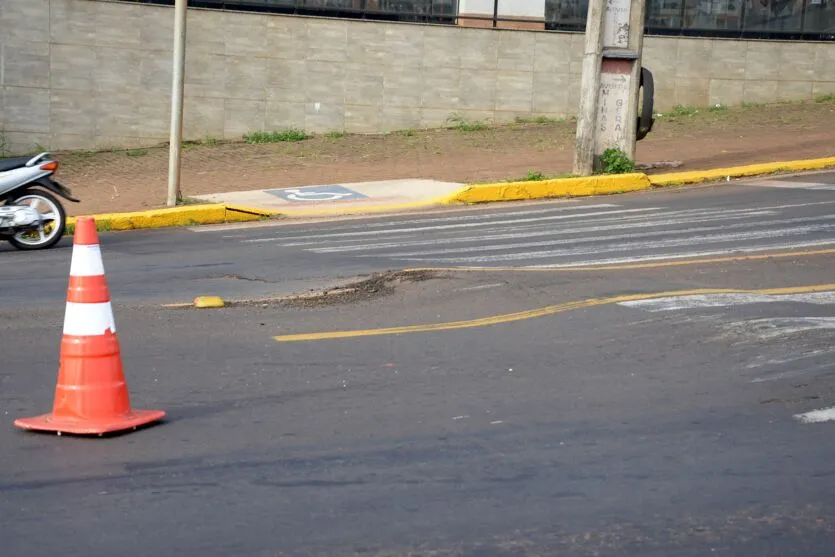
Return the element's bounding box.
[574,0,646,176]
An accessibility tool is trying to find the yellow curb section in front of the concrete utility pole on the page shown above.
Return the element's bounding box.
[449,172,651,203]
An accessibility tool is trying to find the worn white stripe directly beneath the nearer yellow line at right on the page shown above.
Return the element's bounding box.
[618,292,835,310]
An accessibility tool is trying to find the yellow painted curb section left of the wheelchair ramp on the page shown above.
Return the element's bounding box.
[67,204,275,230]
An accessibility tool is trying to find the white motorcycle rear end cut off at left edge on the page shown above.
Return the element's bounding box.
[0,153,79,250]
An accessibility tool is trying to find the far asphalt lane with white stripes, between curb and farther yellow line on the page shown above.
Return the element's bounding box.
[0,169,835,307]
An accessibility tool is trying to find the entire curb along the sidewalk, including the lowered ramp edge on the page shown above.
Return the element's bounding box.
[67,157,835,230]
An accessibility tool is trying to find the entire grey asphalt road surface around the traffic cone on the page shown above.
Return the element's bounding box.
[0,172,835,557]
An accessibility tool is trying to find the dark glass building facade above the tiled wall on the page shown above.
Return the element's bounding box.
[125,0,835,41]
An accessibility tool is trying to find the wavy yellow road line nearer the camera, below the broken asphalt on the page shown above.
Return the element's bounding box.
[273,284,835,342]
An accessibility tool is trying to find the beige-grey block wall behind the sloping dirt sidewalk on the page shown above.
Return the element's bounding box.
[0,0,835,152]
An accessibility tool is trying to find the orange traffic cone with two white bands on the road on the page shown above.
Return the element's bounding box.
[15,217,165,435]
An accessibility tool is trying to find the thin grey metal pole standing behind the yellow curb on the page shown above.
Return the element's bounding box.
[168,0,188,207]
